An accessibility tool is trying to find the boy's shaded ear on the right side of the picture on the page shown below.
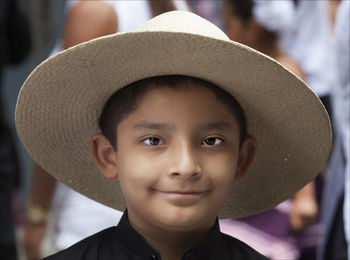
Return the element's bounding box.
[235,136,256,181]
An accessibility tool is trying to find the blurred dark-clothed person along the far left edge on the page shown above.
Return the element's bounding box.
[0,0,31,260]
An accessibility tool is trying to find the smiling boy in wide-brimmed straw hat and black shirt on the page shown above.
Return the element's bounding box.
[16,11,331,259]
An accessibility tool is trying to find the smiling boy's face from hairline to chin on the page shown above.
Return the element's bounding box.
[91,85,255,234]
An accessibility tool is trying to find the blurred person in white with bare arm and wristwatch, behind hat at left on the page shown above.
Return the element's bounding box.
[23,0,188,260]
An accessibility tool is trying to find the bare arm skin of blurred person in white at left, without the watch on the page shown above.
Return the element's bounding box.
[22,0,118,260]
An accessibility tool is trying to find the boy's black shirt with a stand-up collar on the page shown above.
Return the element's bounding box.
[45,211,268,260]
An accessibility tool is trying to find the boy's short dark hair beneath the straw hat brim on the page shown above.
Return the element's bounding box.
[99,75,246,149]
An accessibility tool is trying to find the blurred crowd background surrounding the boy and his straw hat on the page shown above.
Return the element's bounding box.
[0,0,350,260]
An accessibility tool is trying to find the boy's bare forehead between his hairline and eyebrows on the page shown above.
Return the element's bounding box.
[122,82,236,128]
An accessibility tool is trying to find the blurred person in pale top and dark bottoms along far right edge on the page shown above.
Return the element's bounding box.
[318,0,350,260]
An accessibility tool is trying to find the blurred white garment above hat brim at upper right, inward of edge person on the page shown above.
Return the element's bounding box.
[280,0,332,97]
